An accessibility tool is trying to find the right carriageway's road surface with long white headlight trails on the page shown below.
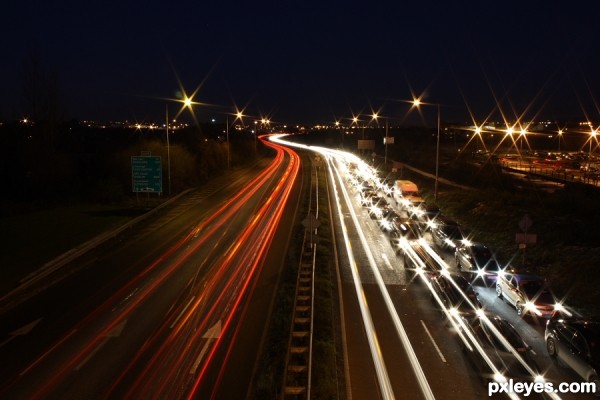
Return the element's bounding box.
[274,135,593,399]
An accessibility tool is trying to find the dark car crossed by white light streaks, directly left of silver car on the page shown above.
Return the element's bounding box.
[428,270,481,313]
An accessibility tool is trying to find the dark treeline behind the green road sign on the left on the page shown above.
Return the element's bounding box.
[0,121,260,210]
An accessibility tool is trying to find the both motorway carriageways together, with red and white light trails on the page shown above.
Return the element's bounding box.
[0,130,591,399]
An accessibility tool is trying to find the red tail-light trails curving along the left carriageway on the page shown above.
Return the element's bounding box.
[8,135,300,398]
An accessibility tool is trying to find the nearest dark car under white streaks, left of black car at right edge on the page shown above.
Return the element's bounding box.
[457,311,539,383]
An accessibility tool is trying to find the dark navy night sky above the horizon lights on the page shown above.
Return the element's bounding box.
[0,0,600,123]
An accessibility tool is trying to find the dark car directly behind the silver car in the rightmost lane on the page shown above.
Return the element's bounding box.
[454,240,500,277]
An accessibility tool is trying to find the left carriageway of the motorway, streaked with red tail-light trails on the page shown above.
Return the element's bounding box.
[0,138,301,399]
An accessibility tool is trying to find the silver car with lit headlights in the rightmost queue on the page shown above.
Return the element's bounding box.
[496,271,557,318]
